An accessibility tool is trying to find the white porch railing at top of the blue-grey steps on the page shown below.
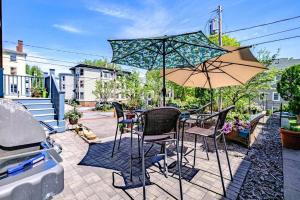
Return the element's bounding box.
[3,74,45,97]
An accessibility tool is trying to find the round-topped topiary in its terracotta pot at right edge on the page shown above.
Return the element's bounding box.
[277,65,300,149]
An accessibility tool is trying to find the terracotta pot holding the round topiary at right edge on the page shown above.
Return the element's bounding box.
[280,128,300,149]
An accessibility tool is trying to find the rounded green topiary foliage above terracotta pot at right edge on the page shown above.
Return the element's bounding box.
[277,65,300,114]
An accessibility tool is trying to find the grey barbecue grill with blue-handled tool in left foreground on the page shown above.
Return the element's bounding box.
[0,99,64,200]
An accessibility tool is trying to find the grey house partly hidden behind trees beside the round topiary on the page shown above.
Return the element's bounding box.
[257,58,300,111]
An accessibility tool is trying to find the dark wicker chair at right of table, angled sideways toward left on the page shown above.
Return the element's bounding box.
[181,106,234,197]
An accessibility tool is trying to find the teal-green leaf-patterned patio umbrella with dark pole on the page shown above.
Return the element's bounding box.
[108,31,227,105]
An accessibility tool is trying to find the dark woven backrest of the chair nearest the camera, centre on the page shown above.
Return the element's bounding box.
[142,107,181,135]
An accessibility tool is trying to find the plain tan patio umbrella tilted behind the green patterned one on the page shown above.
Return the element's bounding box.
[161,46,268,111]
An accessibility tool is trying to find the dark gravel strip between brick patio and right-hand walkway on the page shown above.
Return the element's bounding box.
[239,116,284,199]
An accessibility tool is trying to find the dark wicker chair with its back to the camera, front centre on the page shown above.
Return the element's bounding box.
[135,107,183,199]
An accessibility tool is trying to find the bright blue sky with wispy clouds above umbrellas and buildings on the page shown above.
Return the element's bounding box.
[3,0,300,72]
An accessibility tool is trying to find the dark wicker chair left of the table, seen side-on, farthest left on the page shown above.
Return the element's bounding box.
[111,102,140,157]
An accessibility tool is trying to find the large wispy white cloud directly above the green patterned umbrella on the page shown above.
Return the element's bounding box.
[88,1,188,38]
